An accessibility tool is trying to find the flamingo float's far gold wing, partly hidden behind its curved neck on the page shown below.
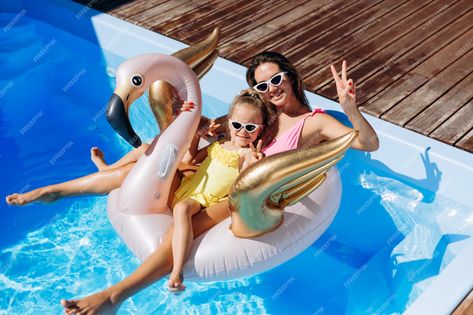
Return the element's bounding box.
[149,27,220,132]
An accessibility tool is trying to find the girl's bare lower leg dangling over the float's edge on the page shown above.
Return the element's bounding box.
[169,198,201,291]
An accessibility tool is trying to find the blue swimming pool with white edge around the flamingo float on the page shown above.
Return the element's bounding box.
[0,0,473,314]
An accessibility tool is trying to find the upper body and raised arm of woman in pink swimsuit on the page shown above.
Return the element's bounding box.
[246,52,379,155]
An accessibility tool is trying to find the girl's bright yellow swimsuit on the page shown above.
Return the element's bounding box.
[173,142,240,208]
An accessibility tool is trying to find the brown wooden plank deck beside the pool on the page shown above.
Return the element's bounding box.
[76,0,473,315]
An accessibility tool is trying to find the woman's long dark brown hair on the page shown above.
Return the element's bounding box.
[246,51,312,111]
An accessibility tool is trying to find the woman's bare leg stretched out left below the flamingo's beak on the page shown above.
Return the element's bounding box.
[6,163,135,206]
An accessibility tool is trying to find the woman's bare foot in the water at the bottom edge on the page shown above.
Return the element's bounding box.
[61,291,121,315]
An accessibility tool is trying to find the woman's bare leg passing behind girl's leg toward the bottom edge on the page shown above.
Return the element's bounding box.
[61,201,230,314]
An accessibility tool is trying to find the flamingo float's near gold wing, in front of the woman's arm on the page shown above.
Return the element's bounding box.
[228,130,358,238]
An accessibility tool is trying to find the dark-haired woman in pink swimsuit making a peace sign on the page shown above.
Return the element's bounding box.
[61,52,379,314]
